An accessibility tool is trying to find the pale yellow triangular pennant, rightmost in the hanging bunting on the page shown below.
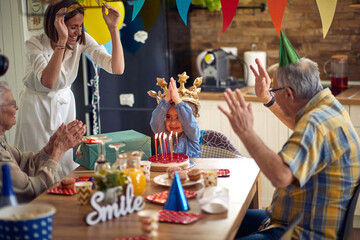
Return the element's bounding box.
[316,0,337,38]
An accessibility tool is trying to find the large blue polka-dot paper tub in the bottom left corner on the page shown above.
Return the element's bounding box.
[0,203,56,240]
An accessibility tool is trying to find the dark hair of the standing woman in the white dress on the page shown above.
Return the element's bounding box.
[44,0,86,49]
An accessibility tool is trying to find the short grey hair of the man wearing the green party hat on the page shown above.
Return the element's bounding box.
[276,58,323,100]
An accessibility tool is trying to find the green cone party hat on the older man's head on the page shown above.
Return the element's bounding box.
[279,31,300,67]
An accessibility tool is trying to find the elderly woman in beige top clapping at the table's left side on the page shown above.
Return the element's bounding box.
[0,81,86,202]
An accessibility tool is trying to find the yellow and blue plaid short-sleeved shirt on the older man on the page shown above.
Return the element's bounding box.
[267,89,360,239]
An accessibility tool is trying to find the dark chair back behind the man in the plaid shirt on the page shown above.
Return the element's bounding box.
[339,184,360,240]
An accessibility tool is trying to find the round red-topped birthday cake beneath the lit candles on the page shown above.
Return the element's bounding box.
[148,153,190,171]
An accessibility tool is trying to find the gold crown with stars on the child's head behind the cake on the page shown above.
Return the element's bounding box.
[147,72,202,106]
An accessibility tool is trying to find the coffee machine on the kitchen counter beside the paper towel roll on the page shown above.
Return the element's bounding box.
[197,49,245,92]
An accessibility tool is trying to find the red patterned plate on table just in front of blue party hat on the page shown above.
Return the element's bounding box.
[159,210,203,224]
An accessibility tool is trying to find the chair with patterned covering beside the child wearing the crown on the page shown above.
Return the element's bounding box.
[200,130,243,158]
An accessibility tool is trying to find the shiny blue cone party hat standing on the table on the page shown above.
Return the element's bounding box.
[164,172,189,211]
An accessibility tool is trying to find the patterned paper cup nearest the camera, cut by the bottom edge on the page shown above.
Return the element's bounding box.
[137,210,159,239]
